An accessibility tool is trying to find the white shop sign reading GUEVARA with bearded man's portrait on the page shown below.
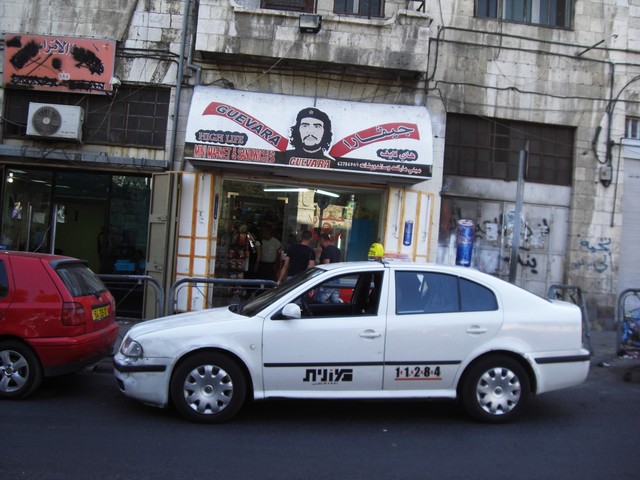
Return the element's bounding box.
[185,87,433,181]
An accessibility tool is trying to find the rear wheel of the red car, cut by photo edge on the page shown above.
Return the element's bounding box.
[0,340,42,399]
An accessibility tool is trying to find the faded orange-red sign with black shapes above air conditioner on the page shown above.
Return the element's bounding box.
[4,33,116,94]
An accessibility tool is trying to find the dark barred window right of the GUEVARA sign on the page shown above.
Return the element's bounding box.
[444,114,574,186]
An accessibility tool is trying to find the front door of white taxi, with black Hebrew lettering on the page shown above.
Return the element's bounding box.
[263,269,385,398]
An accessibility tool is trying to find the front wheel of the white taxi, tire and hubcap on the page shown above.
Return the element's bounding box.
[170,352,247,423]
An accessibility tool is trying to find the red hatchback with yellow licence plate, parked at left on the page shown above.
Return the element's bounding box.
[0,251,118,398]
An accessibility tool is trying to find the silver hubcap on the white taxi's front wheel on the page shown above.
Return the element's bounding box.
[183,365,233,414]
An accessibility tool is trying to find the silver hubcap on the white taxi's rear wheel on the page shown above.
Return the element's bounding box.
[476,367,522,415]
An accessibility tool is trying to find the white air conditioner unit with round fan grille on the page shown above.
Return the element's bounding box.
[27,102,84,141]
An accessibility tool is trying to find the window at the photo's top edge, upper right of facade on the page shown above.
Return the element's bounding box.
[476,0,573,28]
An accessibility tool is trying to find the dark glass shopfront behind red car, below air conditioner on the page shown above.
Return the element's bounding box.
[0,168,150,274]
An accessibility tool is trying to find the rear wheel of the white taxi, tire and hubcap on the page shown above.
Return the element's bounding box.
[461,355,532,423]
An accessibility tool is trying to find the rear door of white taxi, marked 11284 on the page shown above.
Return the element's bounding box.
[384,270,502,390]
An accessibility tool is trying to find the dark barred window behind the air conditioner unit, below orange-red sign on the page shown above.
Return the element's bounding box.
[5,86,171,148]
